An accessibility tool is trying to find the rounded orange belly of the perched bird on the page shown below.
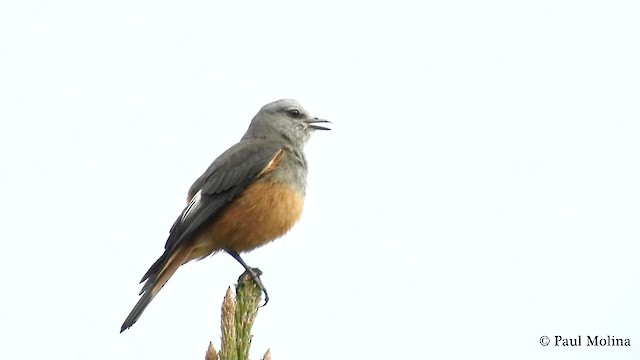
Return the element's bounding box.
[189,180,304,259]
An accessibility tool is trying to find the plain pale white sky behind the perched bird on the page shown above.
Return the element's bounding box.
[0,0,640,360]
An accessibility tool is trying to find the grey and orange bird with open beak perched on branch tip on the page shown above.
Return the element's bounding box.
[120,99,331,332]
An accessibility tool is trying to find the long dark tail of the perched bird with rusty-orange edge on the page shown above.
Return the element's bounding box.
[120,246,190,332]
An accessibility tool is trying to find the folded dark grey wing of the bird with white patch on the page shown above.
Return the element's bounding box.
[140,139,283,284]
